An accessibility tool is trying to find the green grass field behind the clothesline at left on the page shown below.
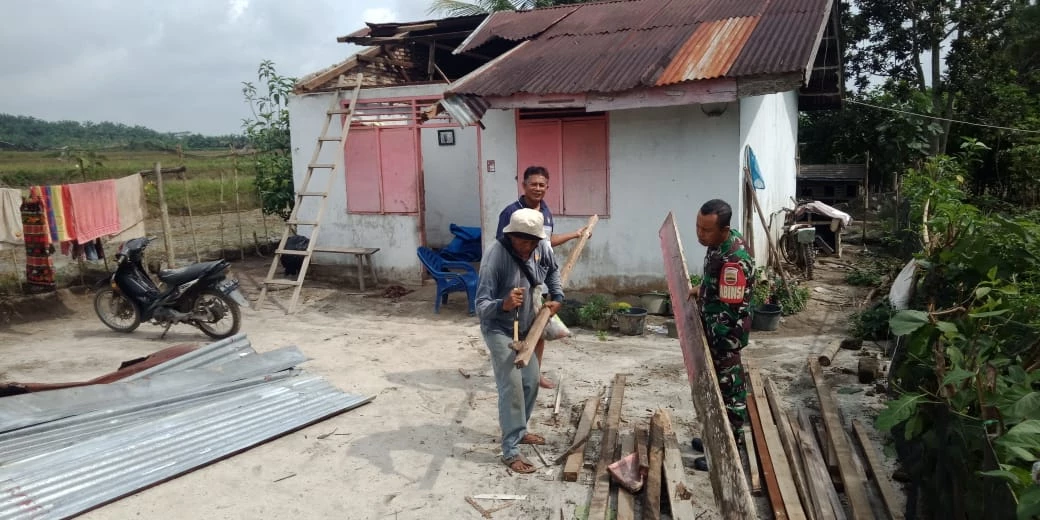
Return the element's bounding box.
[0,150,259,214]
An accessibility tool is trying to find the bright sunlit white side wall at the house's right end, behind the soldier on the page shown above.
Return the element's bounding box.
[734,90,798,265]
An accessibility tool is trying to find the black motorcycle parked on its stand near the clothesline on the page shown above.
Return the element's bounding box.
[94,237,249,339]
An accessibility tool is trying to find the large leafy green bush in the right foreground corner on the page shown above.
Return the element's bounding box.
[877,144,1040,519]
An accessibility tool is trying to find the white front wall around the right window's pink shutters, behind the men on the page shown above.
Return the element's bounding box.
[482,103,740,291]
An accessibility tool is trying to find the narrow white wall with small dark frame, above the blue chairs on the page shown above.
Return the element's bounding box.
[421,127,480,248]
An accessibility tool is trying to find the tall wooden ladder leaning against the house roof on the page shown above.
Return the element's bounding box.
[255,73,362,314]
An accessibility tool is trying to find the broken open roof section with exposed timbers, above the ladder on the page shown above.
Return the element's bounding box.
[294,15,497,94]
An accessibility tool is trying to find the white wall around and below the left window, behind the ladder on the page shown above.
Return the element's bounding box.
[289,85,444,283]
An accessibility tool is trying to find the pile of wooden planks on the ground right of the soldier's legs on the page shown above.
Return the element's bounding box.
[745,356,903,520]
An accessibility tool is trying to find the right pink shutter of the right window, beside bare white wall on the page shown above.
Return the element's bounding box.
[561,119,609,215]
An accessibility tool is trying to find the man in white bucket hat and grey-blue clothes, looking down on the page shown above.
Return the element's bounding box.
[476,208,564,473]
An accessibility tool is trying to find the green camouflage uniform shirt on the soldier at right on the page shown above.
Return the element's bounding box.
[701,230,755,350]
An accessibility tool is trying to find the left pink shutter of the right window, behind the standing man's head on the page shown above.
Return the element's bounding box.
[517,121,563,212]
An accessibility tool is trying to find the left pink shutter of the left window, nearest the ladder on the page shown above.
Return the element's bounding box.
[344,128,383,213]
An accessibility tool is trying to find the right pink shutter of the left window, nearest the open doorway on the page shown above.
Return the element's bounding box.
[373,127,419,213]
